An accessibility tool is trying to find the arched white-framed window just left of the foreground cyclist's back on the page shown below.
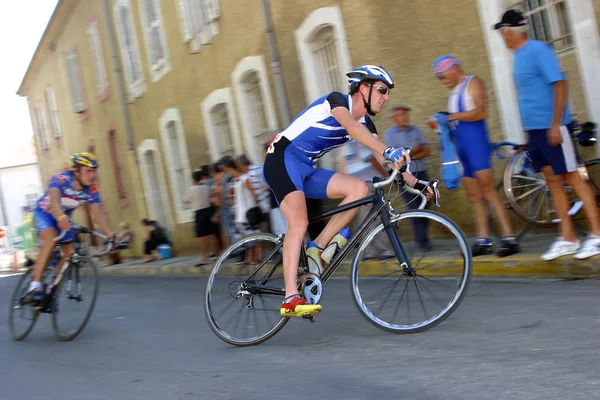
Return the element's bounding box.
[231,56,277,161]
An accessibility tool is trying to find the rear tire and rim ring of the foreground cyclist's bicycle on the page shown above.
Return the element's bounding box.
[204,233,289,347]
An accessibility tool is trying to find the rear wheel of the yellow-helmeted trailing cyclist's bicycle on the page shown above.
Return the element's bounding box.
[8,269,40,340]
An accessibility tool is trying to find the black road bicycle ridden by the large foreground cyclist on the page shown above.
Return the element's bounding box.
[204,166,473,346]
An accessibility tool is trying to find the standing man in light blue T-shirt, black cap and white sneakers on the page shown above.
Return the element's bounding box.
[494,10,600,260]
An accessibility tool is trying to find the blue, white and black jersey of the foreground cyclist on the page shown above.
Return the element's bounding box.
[281,92,376,162]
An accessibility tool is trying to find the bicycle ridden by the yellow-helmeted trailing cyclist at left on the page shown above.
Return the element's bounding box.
[8,223,113,340]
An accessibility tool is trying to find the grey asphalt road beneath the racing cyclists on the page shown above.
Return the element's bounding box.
[0,276,600,400]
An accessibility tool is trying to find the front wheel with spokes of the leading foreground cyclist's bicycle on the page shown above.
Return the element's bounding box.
[351,210,473,333]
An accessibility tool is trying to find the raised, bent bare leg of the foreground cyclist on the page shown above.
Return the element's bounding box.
[315,172,369,247]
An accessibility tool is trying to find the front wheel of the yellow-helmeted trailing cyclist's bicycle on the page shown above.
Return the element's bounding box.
[52,257,100,341]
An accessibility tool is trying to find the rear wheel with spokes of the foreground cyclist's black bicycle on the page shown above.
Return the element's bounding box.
[204,233,288,346]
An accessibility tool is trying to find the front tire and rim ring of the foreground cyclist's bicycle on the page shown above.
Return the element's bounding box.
[350,210,473,334]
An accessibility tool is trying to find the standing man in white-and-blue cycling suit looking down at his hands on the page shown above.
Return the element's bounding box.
[433,55,521,257]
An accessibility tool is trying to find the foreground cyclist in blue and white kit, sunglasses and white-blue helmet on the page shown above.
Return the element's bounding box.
[263,65,416,317]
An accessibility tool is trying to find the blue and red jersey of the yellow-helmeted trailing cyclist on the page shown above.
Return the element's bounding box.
[34,172,100,243]
